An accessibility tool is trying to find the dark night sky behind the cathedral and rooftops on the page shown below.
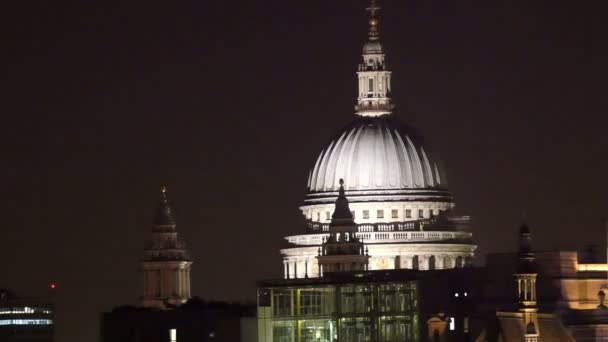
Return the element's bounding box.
[0,0,608,342]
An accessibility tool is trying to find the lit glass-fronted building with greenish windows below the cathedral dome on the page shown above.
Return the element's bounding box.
[258,281,420,342]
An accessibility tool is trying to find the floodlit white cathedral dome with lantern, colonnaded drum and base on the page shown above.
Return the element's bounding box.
[281,0,476,278]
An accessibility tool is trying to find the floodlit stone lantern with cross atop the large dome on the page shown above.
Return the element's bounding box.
[355,0,394,116]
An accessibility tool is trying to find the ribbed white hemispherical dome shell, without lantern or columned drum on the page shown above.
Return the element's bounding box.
[308,115,447,192]
